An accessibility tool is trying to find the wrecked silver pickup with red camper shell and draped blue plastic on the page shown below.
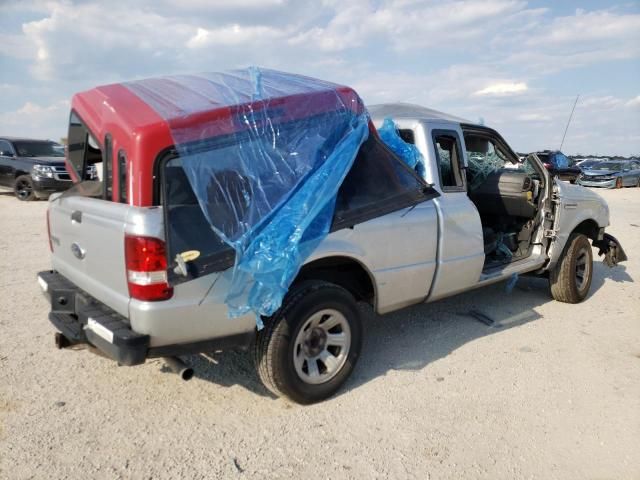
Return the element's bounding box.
[38,69,625,403]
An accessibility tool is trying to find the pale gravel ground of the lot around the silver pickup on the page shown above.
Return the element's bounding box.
[0,189,640,479]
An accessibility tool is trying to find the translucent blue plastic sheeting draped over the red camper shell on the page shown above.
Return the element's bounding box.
[126,67,368,327]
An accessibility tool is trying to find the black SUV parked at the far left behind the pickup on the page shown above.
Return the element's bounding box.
[0,137,79,200]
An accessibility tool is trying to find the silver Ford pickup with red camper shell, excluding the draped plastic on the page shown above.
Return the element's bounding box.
[38,78,626,403]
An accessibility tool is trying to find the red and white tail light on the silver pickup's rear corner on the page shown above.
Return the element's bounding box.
[124,235,173,302]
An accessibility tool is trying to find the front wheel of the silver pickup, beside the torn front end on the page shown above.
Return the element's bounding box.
[549,233,593,303]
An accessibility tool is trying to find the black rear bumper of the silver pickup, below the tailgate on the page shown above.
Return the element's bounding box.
[38,271,254,365]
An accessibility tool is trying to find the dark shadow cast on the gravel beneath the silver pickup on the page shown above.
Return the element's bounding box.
[169,261,633,398]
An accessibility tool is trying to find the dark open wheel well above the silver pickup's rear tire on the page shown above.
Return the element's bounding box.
[295,257,375,306]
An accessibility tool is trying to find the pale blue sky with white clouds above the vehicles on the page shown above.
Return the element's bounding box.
[0,0,640,156]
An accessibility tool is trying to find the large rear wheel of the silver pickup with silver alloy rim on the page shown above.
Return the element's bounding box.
[254,280,362,405]
